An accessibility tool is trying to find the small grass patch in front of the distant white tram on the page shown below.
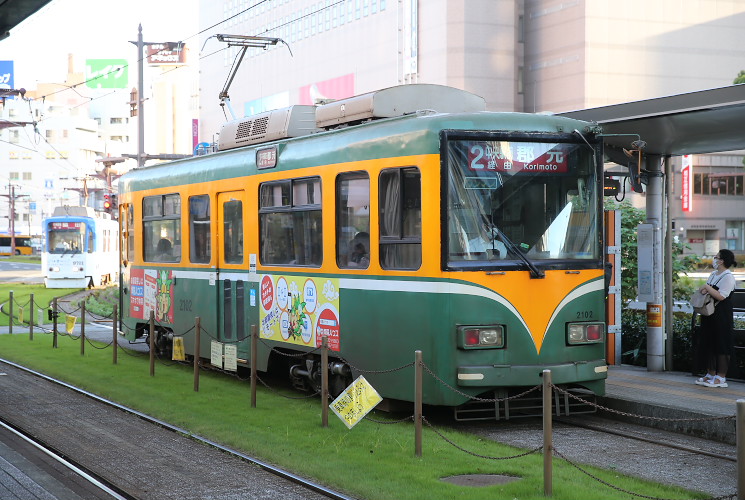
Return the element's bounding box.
[0,283,82,326]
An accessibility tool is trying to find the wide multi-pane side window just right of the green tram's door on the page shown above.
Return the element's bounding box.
[259,177,323,267]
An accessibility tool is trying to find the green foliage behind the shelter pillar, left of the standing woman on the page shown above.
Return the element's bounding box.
[606,201,698,303]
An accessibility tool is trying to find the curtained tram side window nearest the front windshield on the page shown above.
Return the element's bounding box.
[379,167,422,270]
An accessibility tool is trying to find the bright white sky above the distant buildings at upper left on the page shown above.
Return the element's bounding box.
[0,0,201,89]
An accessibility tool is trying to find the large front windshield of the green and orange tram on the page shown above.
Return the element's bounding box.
[445,140,601,266]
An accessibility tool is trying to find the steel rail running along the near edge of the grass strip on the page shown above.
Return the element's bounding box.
[0,358,353,500]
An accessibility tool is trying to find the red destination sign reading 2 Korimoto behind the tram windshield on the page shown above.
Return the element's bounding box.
[468,142,569,174]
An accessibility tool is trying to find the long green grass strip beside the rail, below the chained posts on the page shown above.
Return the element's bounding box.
[0,335,708,500]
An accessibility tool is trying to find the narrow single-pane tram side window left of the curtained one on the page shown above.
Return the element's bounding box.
[336,172,370,269]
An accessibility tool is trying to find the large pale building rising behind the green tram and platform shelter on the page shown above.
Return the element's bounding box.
[199,0,745,253]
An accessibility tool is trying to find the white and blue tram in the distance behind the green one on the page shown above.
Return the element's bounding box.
[41,207,119,288]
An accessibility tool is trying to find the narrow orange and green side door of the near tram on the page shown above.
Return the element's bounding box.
[216,191,251,358]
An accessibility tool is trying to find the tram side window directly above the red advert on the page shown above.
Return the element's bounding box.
[142,194,181,262]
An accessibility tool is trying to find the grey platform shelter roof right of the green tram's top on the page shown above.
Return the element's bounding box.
[557,84,745,156]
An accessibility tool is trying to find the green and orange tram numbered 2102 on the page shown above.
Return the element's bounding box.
[119,84,607,418]
